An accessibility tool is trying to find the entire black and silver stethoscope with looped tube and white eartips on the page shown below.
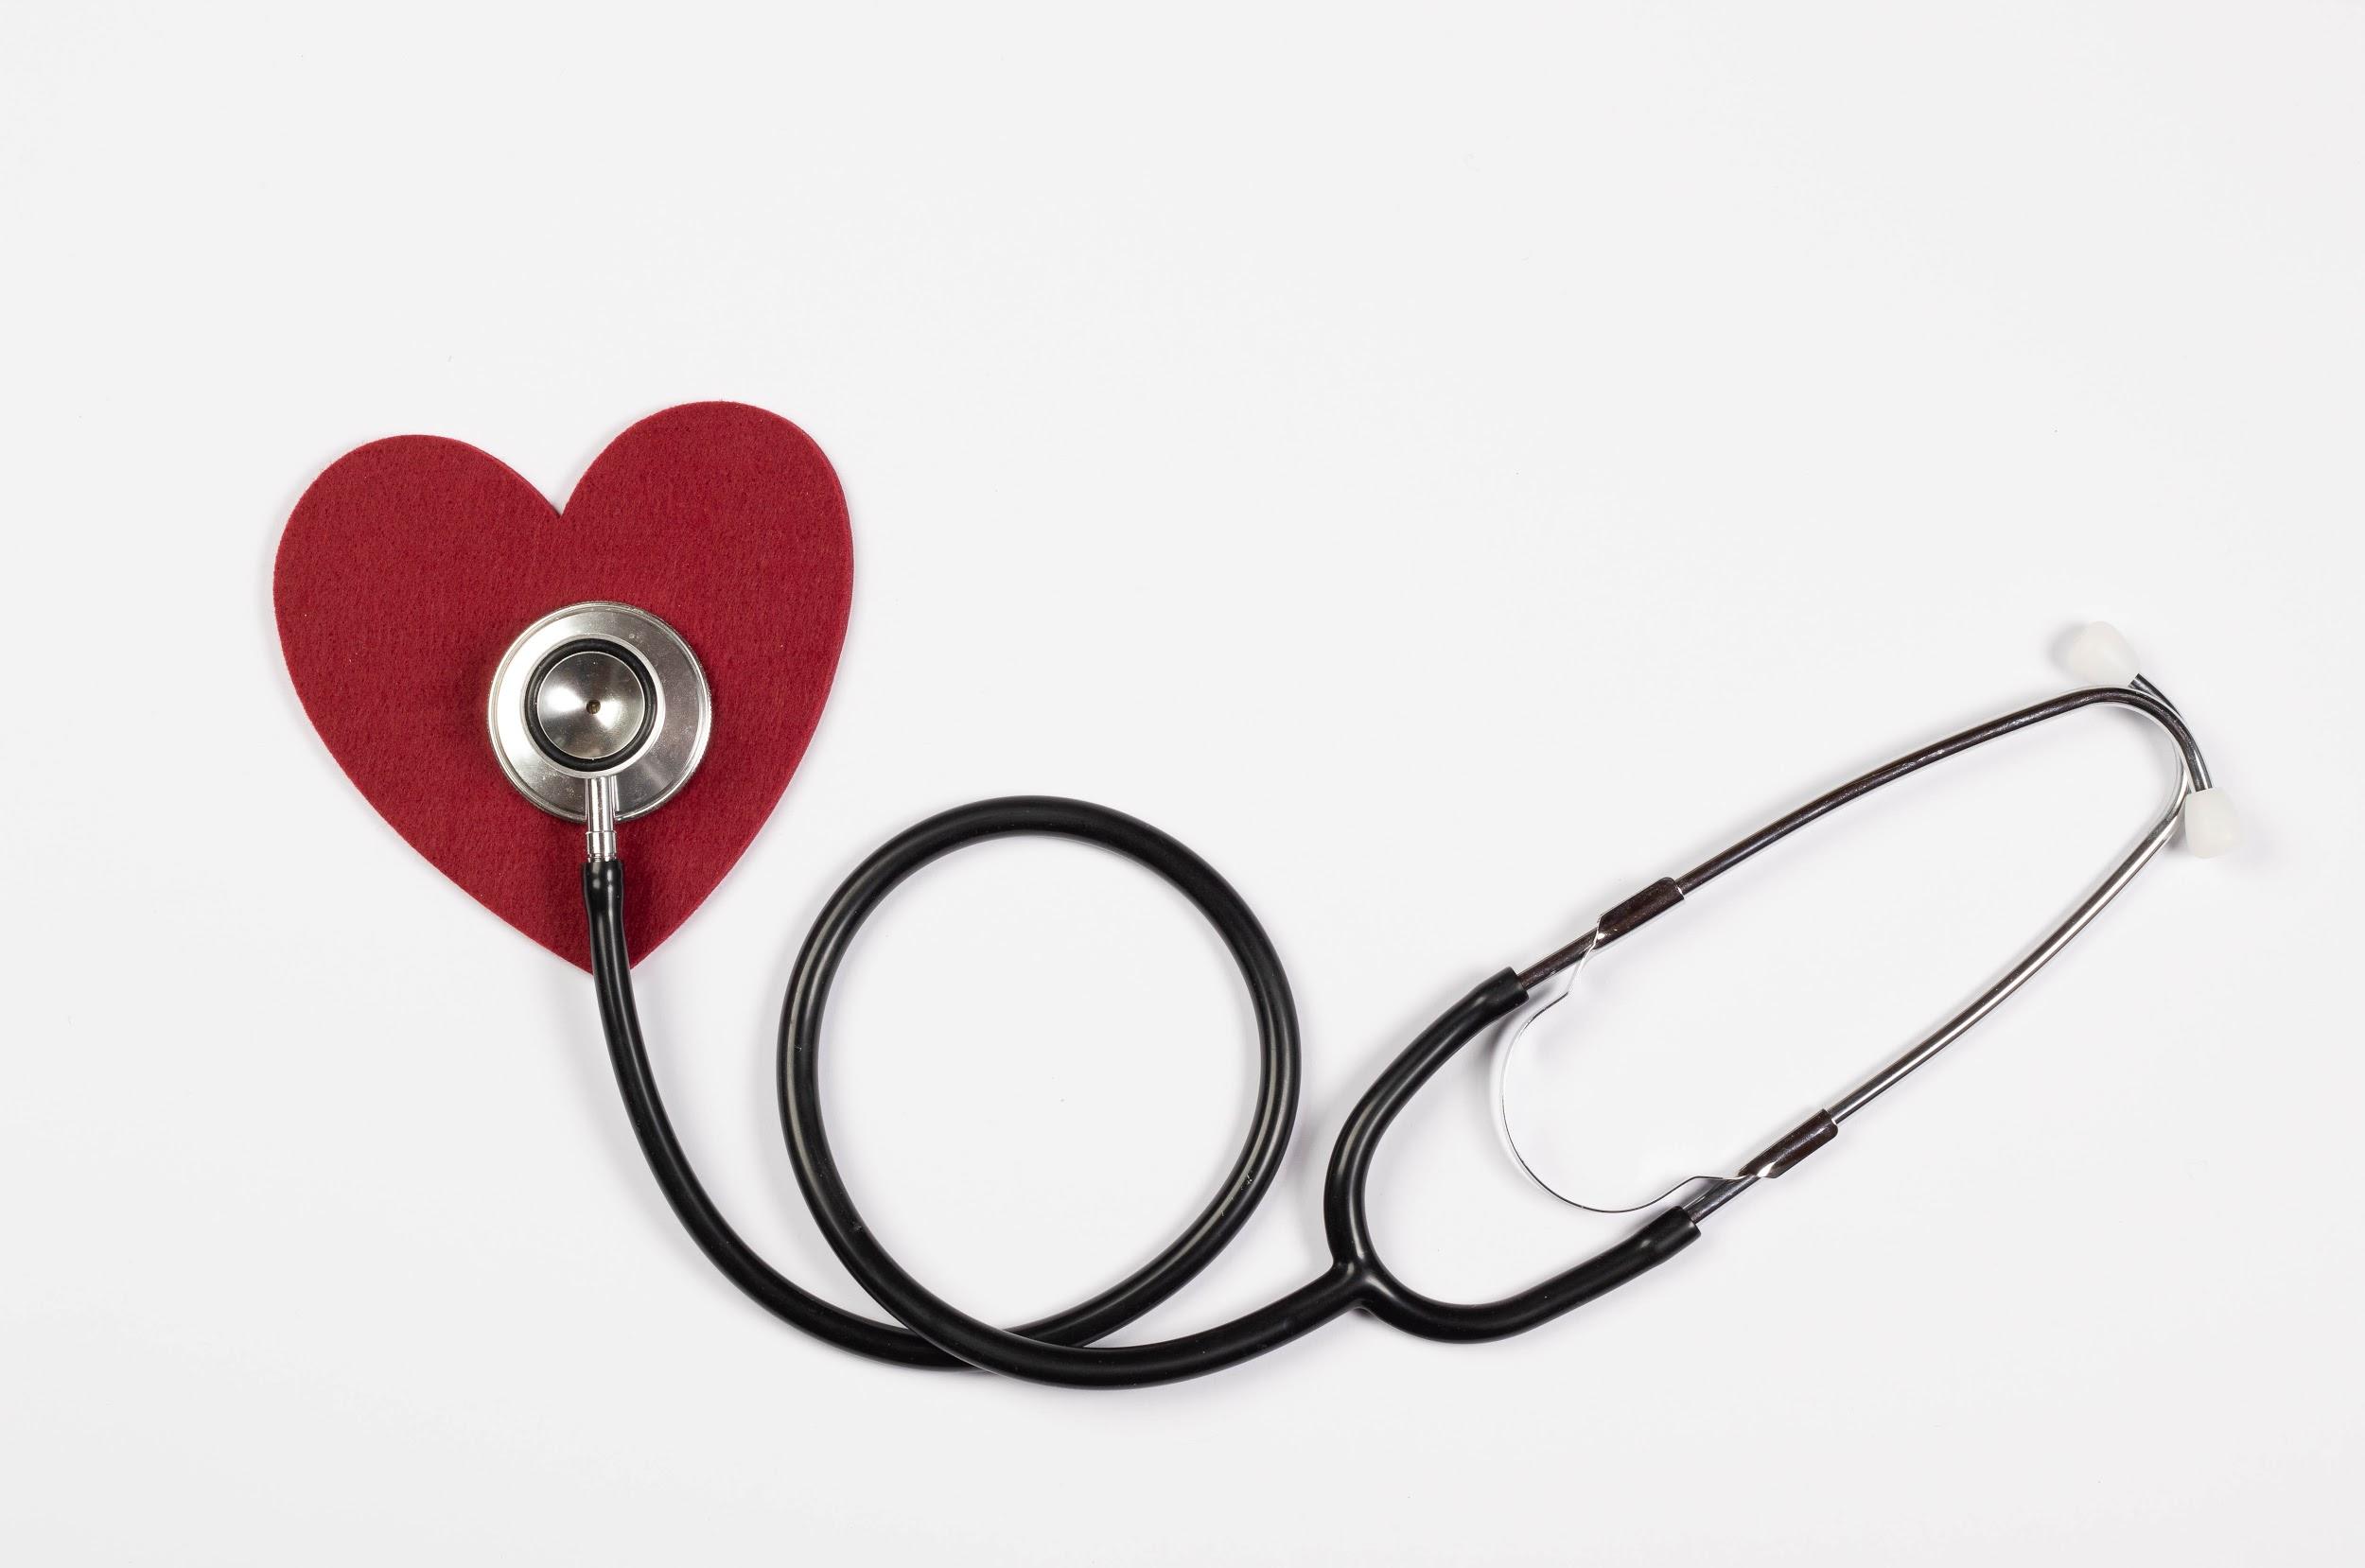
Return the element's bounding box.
[487,603,2240,1388]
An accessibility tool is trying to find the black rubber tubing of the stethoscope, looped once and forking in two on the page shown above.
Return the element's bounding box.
[585,797,1701,1388]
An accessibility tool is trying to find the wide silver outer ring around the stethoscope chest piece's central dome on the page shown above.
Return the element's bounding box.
[485,601,714,823]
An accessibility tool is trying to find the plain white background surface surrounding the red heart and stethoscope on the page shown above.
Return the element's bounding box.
[0,3,2365,1565]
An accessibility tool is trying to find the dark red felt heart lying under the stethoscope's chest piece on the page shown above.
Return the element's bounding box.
[272,402,854,965]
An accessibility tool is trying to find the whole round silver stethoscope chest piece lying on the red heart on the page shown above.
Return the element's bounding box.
[485,601,712,823]
